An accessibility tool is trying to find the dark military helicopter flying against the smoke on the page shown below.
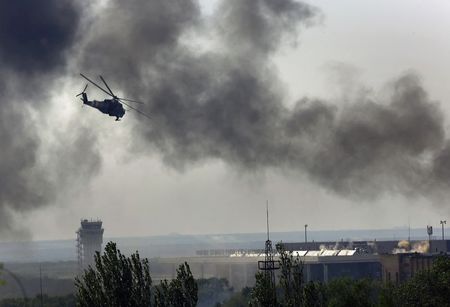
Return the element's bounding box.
[75,74,150,121]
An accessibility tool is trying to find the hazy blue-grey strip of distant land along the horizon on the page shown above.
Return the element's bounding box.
[0,228,450,263]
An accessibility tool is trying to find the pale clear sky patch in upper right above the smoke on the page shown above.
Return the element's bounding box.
[279,0,450,104]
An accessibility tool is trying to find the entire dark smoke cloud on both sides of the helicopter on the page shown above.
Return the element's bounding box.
[0,0,450,238]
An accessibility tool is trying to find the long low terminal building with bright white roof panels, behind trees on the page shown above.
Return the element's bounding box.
[151,240,450,290]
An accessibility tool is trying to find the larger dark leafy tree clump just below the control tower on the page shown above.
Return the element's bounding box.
[75,242,152,307]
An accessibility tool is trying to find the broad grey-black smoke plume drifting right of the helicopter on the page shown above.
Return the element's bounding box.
[80,0,450,205]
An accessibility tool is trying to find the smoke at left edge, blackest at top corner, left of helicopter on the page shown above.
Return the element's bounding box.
[0,0,100,238]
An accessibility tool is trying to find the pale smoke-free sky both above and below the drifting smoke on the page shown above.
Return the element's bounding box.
[3,0,450,239]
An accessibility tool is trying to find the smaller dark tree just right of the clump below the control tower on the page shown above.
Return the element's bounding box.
[155,262,198,307]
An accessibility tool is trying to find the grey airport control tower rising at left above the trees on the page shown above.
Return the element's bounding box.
[77,219,104,270]
